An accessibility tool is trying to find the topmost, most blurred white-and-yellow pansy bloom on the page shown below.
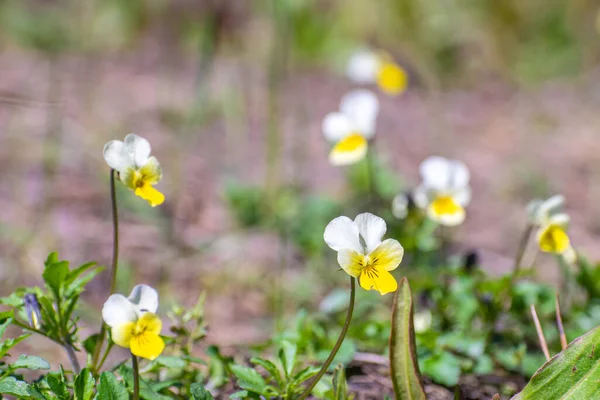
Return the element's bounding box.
[347,50,408,95]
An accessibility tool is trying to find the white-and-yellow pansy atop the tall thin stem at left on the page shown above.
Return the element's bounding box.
[104,133,165,207]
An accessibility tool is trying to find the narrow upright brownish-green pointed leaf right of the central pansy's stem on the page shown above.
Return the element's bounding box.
[390,278,426,400]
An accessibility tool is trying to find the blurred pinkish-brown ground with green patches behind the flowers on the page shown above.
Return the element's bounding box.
[0,0,600,362]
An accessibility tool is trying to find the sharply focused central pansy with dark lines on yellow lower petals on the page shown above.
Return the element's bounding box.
[323,213,404,295]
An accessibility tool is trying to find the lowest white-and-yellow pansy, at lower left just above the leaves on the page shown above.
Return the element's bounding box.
[102,285,165,360]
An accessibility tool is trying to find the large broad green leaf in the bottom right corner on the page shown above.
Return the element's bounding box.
[513,327,600,400]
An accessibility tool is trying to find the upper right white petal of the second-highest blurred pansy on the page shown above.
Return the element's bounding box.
[340,89,379,139]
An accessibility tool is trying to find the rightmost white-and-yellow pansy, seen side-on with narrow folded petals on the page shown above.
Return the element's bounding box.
[527,195,573,258]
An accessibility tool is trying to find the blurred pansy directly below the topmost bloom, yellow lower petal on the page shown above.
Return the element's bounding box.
[322,89,379,165]
